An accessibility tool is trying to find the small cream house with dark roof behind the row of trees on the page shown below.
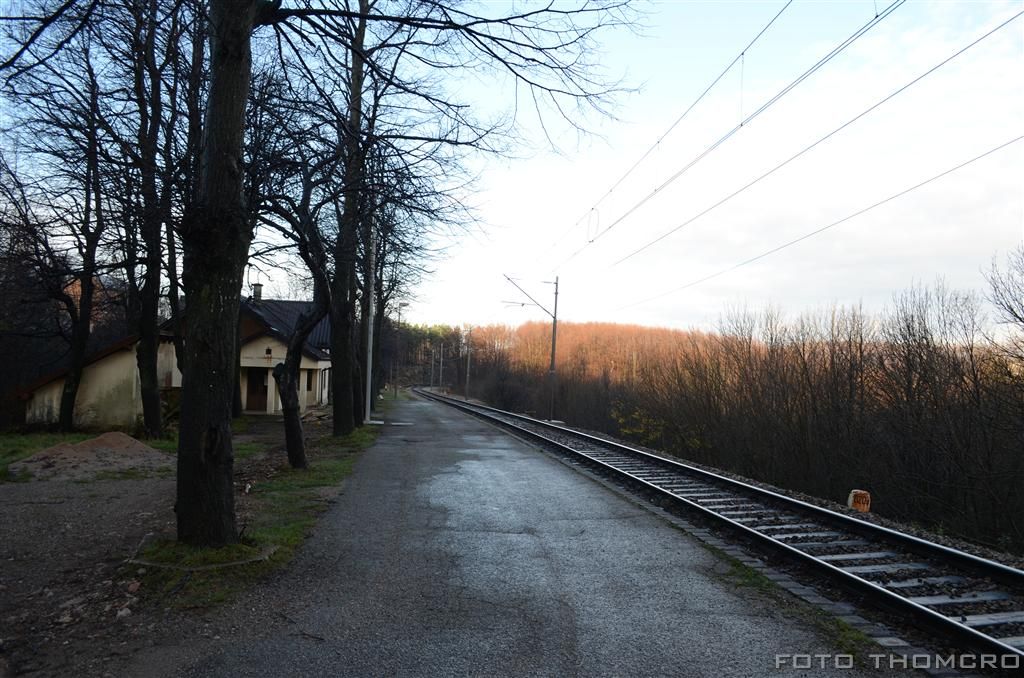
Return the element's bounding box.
[24,292,331,428]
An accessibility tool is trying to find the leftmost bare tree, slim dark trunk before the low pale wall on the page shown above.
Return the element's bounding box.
[2,40,108,430]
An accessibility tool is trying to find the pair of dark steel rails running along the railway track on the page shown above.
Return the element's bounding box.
[417,389,1024,662]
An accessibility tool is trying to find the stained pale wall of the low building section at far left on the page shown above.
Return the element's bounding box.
[25,347,142,428]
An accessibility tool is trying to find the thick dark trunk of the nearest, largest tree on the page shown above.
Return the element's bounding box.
[174,0,256,546]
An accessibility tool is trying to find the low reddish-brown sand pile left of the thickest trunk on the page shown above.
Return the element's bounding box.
[9,431,174,480]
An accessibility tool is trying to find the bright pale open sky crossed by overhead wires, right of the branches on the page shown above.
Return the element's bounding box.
[402,0,1024,330]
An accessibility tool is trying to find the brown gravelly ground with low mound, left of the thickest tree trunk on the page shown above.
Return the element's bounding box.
[0,417,292,678]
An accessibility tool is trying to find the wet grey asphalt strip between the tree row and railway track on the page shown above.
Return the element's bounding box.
[129,400,905,678]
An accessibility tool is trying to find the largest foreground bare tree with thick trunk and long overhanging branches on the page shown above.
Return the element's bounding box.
[0,0,628,545]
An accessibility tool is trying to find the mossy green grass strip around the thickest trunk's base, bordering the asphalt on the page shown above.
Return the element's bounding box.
[138,426,379,609]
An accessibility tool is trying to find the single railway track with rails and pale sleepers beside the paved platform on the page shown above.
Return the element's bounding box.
[417,390,1024,668]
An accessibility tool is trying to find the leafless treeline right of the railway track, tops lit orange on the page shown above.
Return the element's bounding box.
[407,278,1024,551]
